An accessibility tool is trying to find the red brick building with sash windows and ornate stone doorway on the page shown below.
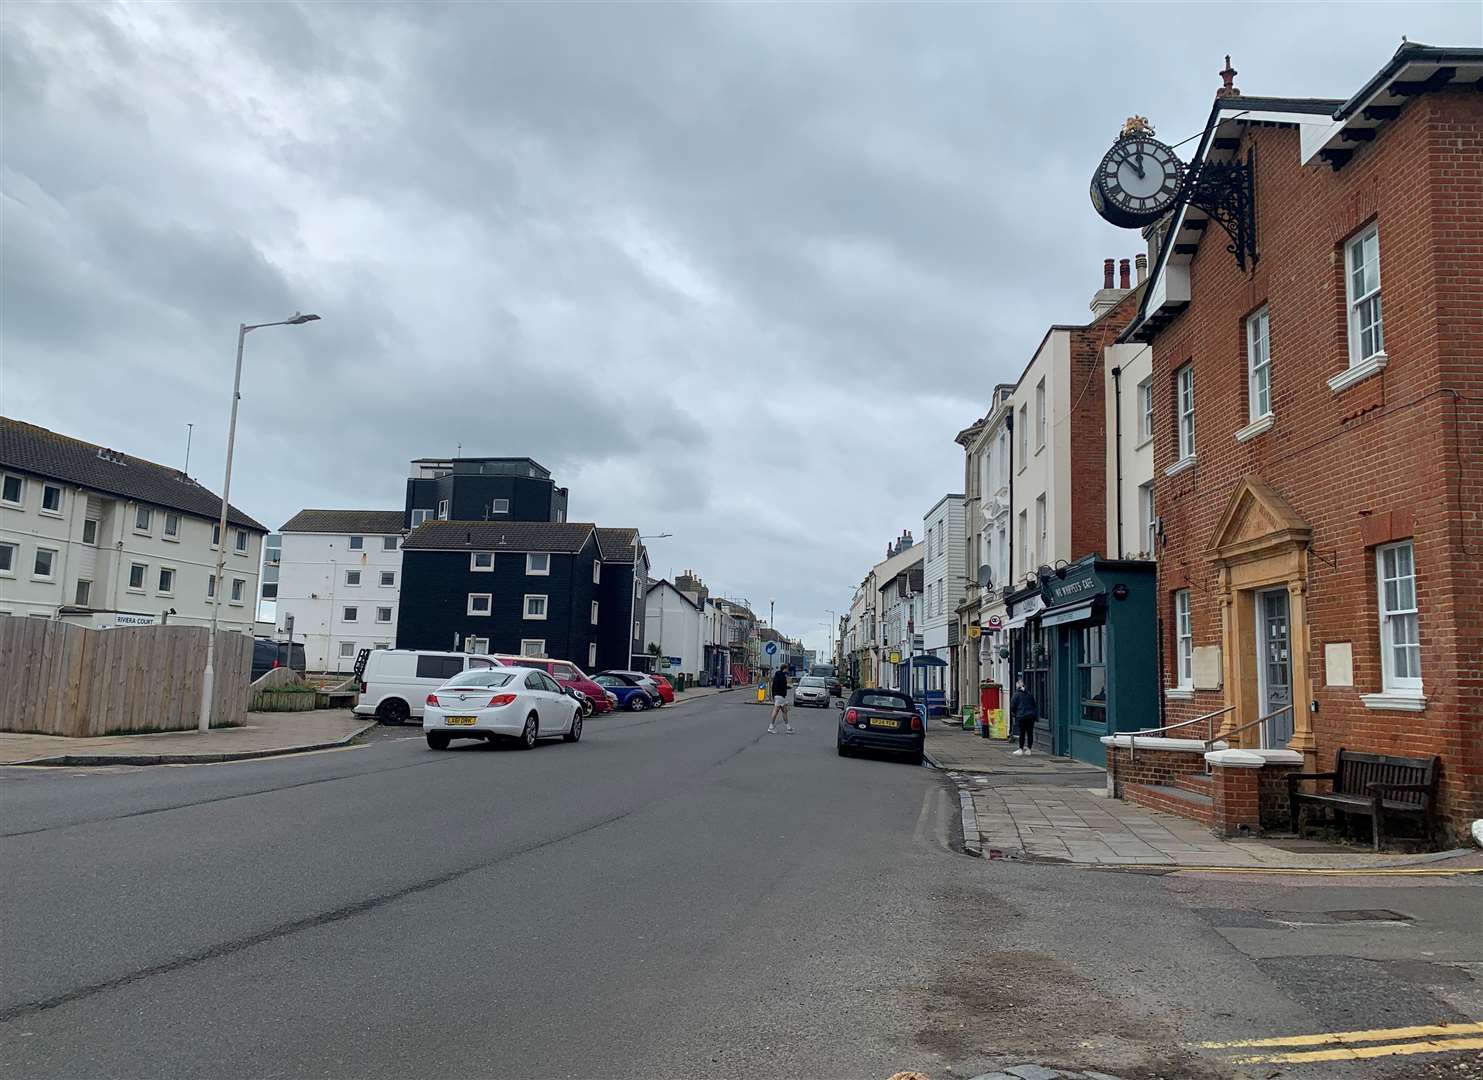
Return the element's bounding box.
[1124,45,1483,834]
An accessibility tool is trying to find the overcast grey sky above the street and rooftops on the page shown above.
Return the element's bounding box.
[0,0,1483,644]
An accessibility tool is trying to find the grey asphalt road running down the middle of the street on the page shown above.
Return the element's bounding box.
[0,694,1483,1080]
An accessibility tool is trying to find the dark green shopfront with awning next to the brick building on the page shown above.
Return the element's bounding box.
[1038,555,1158,765]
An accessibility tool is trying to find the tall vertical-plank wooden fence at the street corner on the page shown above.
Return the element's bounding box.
[0,617,252,737]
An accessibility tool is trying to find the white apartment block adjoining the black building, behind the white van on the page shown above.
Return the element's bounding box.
[277,510,403,672]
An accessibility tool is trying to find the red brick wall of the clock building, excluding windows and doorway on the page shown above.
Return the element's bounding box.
[1154,89,1483,834]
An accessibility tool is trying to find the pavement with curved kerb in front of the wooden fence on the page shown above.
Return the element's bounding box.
[0,709,377,765]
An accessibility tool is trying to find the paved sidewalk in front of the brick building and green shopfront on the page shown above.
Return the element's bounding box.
[927,721,1483,872]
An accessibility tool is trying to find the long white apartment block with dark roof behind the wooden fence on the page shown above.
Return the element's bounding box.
[0,417,267,633]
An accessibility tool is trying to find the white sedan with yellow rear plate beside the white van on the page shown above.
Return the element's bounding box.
[423,668,581,751]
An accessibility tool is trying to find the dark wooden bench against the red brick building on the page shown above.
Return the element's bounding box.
[1287,749,1441,852]
